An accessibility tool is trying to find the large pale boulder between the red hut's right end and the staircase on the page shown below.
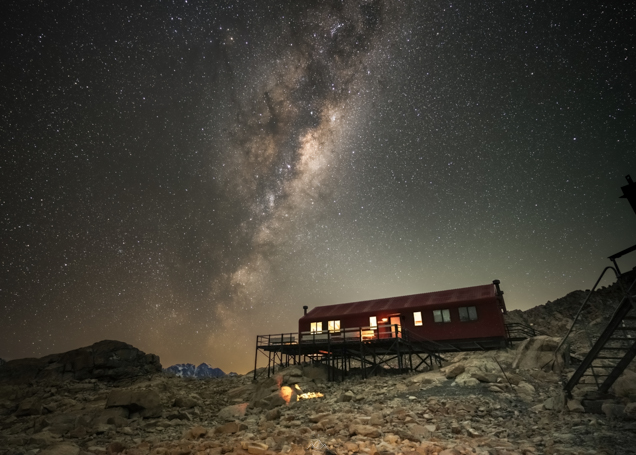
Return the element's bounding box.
[512,335,569,372]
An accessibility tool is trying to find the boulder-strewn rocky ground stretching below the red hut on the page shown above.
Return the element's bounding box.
[0,338,636,455]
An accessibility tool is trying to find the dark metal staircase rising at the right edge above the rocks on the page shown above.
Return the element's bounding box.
[564,274,636,395]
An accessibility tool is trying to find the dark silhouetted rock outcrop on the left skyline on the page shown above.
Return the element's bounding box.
[0,340,161,384]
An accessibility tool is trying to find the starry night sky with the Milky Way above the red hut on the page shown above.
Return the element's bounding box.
[0,0,636,373]
